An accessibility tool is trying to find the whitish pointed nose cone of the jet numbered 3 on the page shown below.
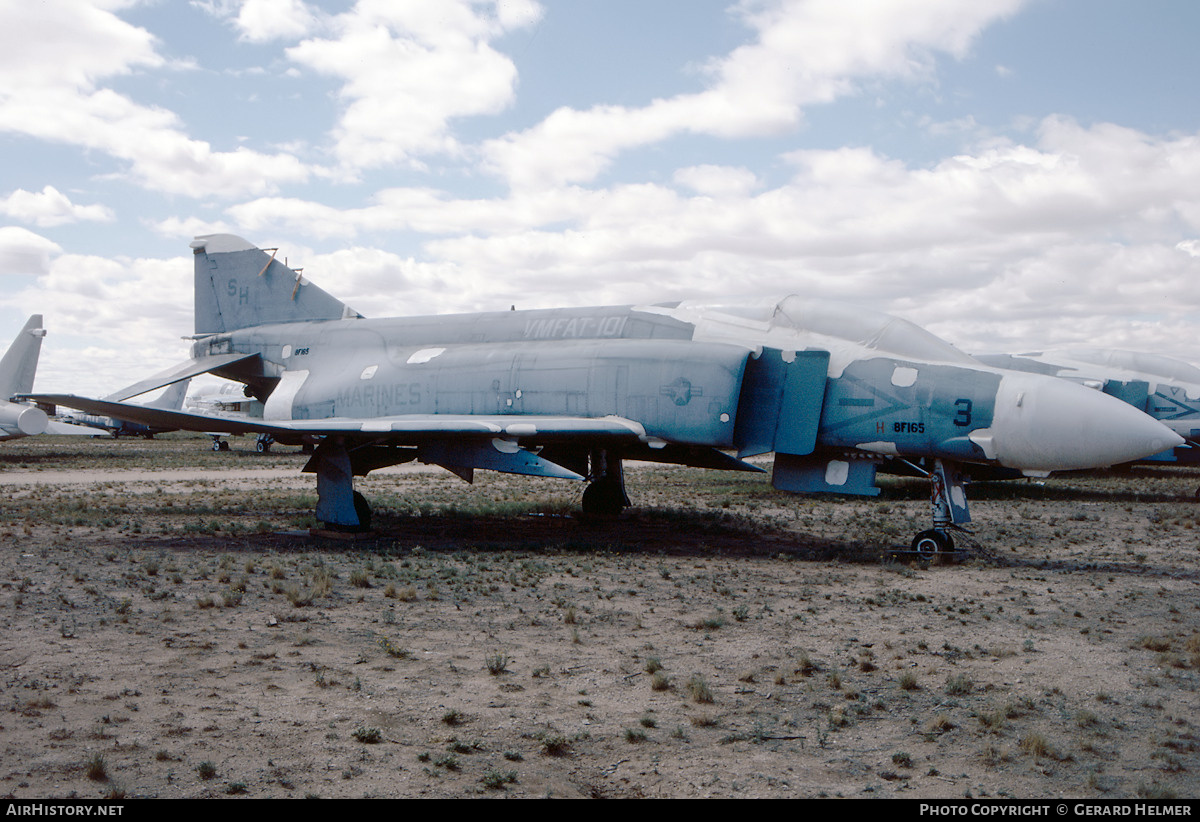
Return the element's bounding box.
[991,373,1183,472]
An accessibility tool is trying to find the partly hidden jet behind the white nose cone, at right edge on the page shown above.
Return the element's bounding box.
[978,348,1200,464]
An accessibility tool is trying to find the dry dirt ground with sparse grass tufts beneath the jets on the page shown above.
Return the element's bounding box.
[0,438,1200,798]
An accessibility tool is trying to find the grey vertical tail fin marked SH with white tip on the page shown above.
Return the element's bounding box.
[192,234,361,335]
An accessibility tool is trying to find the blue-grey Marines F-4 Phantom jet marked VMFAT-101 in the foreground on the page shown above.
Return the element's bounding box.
[37,234,1181,553]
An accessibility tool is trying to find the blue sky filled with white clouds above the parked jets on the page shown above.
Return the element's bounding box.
[0,0,1200,394]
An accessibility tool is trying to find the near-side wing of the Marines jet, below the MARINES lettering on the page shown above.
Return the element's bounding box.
[26,394,646,444]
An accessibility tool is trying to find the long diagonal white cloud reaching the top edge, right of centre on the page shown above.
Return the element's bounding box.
[482,0,1025,187]
